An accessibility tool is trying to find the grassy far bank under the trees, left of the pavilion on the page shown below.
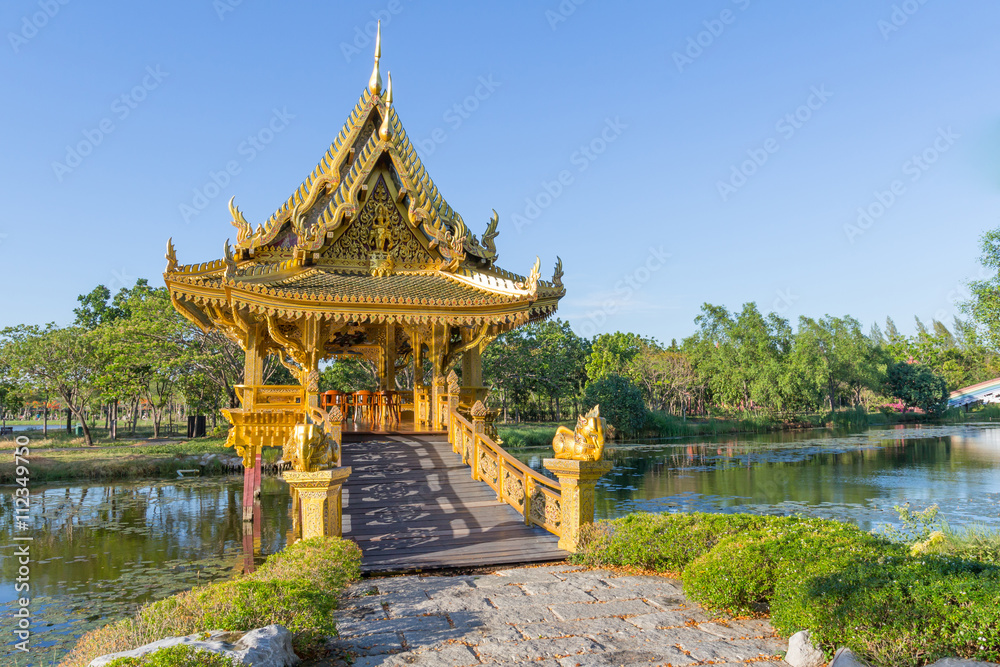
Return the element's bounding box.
[0,436,234,484]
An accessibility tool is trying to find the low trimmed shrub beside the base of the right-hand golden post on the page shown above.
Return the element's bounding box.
[573,512,777,572]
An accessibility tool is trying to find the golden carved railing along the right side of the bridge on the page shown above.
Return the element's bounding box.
[448,409,562,536]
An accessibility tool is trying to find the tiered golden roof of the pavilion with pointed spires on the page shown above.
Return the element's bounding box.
[164,23,565,329]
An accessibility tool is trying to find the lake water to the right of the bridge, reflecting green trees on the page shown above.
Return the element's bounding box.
[520,424,1000,529]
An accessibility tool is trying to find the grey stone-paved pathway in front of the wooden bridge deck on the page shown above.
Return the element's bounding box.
[323,565,787,667]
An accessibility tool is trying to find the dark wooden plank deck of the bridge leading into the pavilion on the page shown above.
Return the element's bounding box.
[343,435,568,572]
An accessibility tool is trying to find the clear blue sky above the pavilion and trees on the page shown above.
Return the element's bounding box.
[0,0,1000,341]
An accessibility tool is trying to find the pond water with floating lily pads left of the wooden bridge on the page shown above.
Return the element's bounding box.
[0,476,290,665]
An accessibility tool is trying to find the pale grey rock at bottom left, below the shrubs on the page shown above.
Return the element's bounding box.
[89,625,299,667]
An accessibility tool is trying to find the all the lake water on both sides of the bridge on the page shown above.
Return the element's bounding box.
[0,424,1000,665]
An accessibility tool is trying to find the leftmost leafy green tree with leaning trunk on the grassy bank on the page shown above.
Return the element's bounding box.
[0,324,107,445]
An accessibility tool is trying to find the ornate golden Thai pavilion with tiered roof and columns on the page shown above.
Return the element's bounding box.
[163,23,565,467]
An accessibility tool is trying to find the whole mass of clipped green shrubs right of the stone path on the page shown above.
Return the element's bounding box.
[573,513,1000,667]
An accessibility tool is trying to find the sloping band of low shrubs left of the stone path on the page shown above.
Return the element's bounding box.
[60,537,361,667]
